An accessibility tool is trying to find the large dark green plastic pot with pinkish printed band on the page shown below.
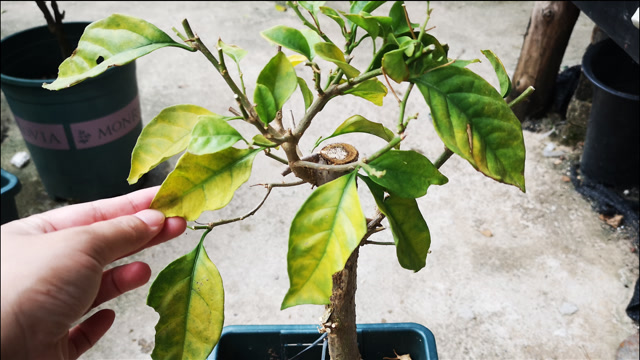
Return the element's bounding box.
[1,22,142,201]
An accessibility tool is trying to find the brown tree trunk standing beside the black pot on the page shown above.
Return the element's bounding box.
[507,1,580,121]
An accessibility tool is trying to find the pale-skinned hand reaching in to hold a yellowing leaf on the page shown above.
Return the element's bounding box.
[0,188,186,359]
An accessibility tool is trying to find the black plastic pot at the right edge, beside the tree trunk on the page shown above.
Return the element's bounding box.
[580,39,640,189]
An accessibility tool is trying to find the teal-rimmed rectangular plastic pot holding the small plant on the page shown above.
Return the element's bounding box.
[207,323,438,360]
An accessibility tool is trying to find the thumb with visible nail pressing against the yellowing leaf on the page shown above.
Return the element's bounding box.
[68,209,165,267]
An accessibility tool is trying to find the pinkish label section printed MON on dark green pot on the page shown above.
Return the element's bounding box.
[70,96,141,149]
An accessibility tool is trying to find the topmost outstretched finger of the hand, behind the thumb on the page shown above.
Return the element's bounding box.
[24,186,159,233]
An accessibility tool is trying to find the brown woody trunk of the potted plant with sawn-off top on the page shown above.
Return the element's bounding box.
[316,144,360,360]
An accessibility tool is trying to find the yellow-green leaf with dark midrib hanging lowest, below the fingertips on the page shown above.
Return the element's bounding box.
[147,237,224,359]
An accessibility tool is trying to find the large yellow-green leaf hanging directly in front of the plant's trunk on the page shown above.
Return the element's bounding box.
[282,171,367,309]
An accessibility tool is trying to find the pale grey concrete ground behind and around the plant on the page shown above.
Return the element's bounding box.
[1,1,638,359]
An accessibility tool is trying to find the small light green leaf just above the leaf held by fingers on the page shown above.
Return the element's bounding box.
[187,115,246,155]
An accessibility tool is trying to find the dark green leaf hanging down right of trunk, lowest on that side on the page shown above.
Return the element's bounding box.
[360,176,431,272]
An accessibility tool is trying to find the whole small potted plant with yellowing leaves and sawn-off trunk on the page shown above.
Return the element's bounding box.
[45,1,529,360]
